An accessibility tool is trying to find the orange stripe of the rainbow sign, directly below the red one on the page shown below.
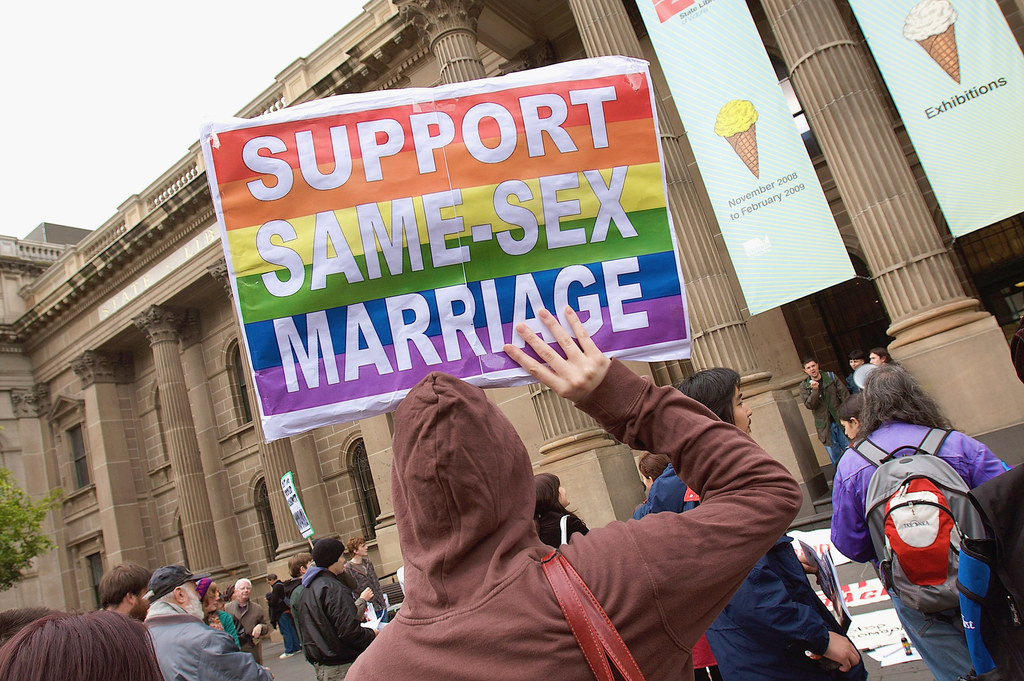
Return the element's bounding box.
[219,119,658,229]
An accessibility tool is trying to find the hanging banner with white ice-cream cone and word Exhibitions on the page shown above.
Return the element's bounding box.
[850,0,1024,237]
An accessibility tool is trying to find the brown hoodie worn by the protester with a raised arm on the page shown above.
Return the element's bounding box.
[347,361,801,681]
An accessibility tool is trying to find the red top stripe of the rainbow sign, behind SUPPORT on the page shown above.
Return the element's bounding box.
[212,75,651,182]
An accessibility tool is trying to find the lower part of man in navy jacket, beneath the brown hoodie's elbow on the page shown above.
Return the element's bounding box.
[708,535,867,681]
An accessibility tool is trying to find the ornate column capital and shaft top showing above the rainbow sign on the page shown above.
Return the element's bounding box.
[394,0,486,83]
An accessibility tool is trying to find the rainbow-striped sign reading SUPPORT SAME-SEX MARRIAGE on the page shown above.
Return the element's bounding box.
[201,57,689,439]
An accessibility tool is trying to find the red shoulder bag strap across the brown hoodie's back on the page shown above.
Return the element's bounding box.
[541,550,645,681]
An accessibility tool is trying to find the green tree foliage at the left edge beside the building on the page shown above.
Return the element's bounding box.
[0,468,63,591]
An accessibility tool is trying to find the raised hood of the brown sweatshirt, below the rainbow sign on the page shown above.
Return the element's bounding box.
[391,373,548,619]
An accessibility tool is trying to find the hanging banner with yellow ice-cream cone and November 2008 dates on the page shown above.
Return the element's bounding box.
[637,0,854,314]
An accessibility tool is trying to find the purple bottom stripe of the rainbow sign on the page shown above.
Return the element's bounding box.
[256,296,686,416]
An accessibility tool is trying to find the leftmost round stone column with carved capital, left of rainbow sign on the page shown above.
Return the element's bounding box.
[132,305,220,569]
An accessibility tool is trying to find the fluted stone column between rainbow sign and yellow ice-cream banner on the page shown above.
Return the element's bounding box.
[569,0,827,499]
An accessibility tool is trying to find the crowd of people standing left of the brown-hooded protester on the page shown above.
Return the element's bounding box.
[0,537,387,681]
